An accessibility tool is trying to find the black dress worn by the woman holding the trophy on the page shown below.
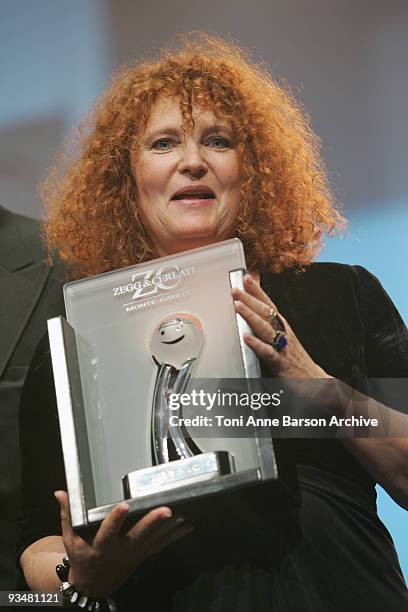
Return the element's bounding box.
[19,264,408,612]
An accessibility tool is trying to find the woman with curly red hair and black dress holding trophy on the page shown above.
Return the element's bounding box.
[20,35,408,612]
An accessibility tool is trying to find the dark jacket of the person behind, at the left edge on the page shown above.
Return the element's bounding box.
[0,207,63,590]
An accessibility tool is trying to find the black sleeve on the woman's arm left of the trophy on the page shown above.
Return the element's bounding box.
[17,333,66,556]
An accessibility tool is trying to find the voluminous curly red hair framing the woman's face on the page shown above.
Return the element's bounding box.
[42,33,344,277]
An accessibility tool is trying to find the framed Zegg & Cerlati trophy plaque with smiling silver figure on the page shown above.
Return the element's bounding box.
[48,239,298,529]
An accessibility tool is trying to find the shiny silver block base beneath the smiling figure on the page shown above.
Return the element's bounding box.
[122,451,235,499]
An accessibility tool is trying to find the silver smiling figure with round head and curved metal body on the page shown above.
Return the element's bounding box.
[149,313,204,463]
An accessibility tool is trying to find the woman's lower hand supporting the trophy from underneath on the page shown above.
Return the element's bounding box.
[55,491,192,598]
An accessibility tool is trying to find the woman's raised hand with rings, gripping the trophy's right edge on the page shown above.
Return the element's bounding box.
[232,274,330,379]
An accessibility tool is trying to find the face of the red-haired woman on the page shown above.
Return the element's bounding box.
[131,97,240,256]
